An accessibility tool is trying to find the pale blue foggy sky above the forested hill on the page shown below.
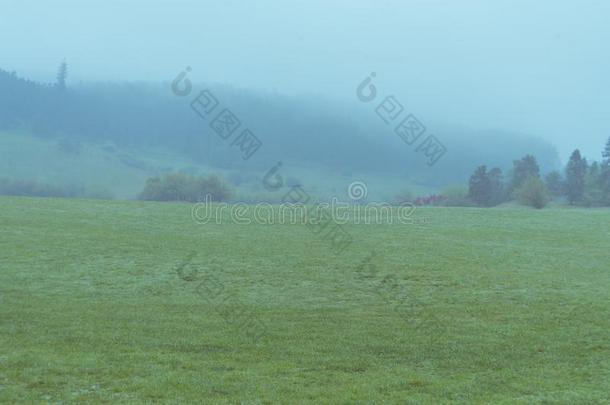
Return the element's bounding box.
[0,0,610,162]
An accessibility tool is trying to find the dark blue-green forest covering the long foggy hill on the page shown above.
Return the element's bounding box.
[0,70,559,186]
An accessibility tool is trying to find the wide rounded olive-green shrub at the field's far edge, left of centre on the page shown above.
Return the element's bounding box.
[138,173,231,202]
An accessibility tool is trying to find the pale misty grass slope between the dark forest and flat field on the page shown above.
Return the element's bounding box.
[0,131,438,201]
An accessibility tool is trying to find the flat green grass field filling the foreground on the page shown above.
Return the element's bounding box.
[0,197,610,404]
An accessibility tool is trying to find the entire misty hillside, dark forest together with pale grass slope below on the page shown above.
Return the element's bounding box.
[0,69,560,198]
